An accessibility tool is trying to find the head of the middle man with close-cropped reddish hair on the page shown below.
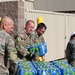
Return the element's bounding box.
[25,20,35,34]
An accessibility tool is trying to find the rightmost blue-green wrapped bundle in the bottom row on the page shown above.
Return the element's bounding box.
[52,60,75,75]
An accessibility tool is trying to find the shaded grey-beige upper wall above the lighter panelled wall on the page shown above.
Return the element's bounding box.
[34,0,75,11]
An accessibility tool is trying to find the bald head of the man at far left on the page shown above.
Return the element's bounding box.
[1,16,14,34]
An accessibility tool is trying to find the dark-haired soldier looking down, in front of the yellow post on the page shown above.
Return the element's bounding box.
[32,23,47,60]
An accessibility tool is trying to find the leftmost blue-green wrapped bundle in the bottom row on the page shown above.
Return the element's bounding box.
[17,60,37,75]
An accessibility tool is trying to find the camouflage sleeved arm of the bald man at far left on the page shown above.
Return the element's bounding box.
[6,38,18,64]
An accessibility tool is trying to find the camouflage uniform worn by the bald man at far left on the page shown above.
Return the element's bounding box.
[0,29,18,75]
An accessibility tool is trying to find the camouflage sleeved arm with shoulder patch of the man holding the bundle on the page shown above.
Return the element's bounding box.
[16,35,29,56]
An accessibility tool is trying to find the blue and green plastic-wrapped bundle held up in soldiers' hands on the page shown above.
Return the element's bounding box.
[28,42,47,56]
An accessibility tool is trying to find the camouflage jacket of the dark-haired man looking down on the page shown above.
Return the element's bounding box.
[32,30,44,44]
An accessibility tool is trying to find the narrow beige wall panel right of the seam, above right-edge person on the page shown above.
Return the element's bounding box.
[65,14,75,44]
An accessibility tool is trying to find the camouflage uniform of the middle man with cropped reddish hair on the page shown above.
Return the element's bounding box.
[16,29,32,59]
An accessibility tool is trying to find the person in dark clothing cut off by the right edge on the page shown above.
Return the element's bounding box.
[65,32,75,67]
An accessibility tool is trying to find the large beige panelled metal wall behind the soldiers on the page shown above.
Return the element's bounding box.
[26,10,75,61]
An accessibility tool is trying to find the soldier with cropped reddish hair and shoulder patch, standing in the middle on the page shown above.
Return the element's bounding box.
[16,20,35,60]
